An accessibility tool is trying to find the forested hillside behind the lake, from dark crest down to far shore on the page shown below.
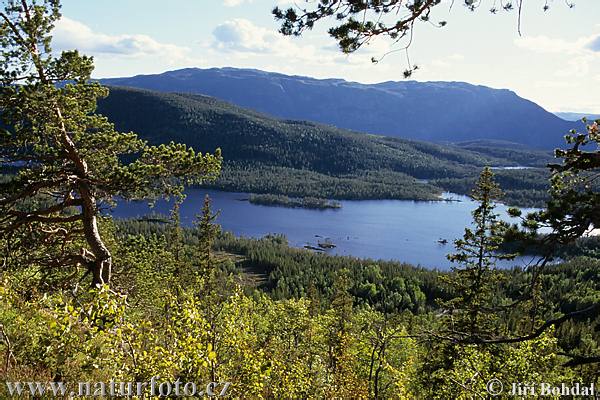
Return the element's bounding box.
[99,87,552,205]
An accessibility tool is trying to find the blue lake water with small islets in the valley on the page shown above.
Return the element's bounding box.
[112,189,540,269]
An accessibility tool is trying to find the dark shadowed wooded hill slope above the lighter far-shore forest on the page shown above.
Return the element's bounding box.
[99,87,548,179]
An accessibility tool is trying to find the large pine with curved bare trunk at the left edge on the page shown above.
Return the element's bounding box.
[0,0,221,285]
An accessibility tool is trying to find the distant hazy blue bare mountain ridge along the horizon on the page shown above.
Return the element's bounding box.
[101,68,573,149]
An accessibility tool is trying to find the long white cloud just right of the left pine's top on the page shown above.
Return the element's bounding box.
[53,17,189,59]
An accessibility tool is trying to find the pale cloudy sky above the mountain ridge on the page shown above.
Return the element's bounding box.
[54,0,600,113]
